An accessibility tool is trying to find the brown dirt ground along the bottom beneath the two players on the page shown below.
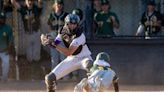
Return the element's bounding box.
[0,81,164,92]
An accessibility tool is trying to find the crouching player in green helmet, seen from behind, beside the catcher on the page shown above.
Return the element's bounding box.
[74,52,119,92]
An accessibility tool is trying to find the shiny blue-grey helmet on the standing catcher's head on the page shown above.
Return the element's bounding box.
[65,14,80,24]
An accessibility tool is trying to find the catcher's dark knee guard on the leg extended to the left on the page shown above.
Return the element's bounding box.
[45,73,56,85]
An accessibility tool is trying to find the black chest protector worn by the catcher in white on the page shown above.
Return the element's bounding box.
[59,27,83,55]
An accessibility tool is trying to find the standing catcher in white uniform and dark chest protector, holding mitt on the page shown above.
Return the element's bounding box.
[41,14,93,92]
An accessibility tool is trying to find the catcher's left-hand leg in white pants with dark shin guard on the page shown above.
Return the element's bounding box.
[45,57,80,92]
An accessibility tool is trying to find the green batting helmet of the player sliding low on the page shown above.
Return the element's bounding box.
[96,52,110,62]
